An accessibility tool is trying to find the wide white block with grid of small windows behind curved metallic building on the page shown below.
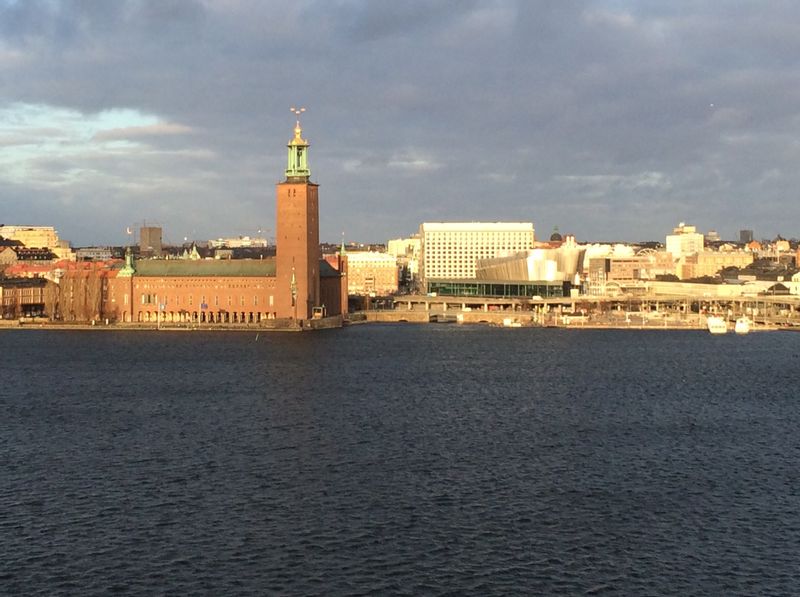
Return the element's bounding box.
[419,222,533,289]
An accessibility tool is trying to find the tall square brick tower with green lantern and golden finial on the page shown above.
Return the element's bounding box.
[275,108,320,319]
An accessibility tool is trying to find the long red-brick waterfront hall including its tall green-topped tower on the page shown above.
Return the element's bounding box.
[6,116,347,325]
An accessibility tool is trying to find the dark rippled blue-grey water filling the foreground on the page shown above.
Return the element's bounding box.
[0,325,800,595]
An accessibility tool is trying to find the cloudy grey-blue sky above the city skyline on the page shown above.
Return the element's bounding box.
[0,0,800,246]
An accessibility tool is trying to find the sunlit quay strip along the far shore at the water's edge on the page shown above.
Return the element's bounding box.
[0,295,800,332]
